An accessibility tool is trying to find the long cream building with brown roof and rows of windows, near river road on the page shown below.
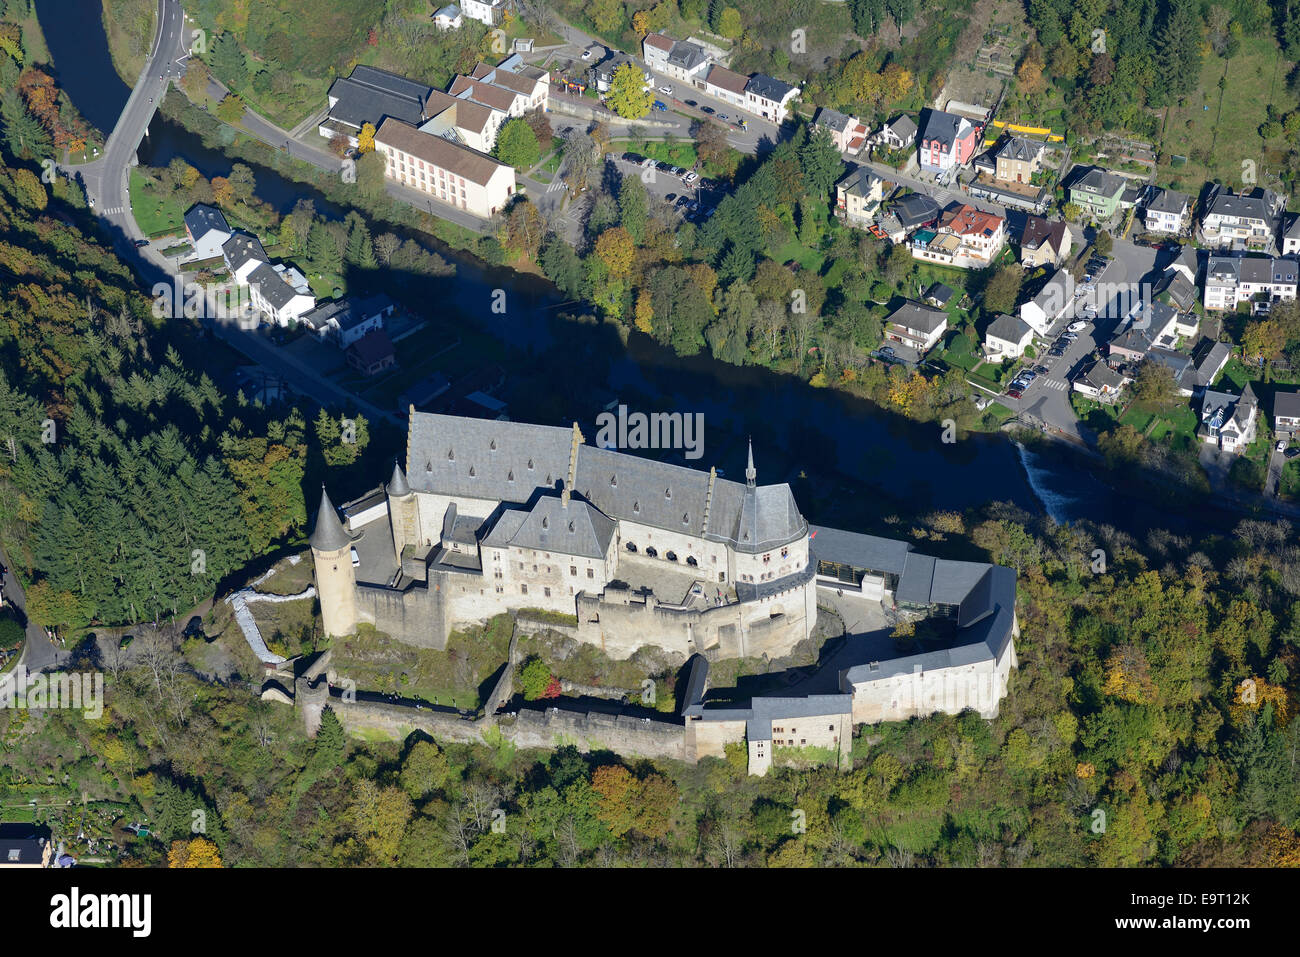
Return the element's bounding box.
[374,120,515,220]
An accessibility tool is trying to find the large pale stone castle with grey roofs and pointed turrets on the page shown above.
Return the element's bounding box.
[311,408,1019,772]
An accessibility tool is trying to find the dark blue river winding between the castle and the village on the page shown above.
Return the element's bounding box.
[38,7,1235,536]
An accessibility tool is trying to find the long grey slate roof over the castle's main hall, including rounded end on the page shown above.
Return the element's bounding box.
[407,412,807,553]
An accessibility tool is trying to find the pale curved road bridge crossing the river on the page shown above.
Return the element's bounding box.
[77,0,189,239]
